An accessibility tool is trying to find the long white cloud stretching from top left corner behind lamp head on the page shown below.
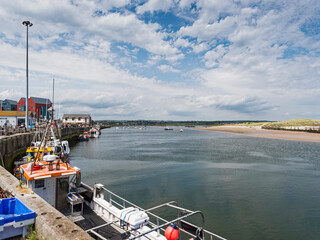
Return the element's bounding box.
[0,0,180,59]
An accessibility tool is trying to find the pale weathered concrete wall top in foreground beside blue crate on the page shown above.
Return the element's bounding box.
[0,166,92,240]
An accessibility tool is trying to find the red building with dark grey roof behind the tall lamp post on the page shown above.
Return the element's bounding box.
[17,97,52,120]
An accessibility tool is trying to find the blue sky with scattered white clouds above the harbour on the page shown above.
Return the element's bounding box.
[0,0,320,120]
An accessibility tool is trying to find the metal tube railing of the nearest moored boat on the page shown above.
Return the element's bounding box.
[102,187,226,240]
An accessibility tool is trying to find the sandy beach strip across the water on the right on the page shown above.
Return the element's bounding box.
[199,125,320,142]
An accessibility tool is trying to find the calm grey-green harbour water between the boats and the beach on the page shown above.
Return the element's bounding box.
[71,127,320,240]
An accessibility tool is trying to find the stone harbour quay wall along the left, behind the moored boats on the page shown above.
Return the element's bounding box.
[0,126,92,239]
